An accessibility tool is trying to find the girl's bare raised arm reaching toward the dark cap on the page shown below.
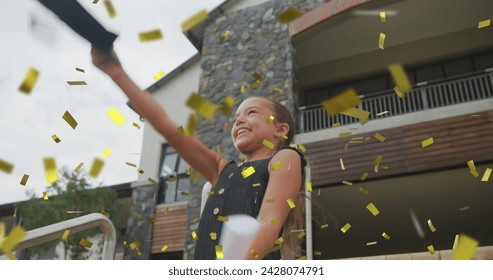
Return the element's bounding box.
[91,48,227,185]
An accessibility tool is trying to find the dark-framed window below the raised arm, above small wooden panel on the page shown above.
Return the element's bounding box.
[157,144,190,204]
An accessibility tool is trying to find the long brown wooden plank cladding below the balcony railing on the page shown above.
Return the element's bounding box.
[305,111,493,186]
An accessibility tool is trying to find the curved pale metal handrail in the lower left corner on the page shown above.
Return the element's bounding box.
[0,213,116,260]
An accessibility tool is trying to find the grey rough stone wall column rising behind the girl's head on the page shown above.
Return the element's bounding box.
[184,0,327,259]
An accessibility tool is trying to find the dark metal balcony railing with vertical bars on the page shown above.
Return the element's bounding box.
[299,72,493,133]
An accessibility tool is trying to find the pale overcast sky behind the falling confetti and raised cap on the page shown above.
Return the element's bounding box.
[0,0,223,204]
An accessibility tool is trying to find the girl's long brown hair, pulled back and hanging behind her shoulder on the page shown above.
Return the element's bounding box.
[260,97,305,260]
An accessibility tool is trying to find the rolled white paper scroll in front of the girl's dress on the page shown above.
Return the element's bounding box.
[219,214,260,260]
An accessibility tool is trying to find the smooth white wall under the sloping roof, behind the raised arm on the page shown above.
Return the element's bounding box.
[138,59,201,182]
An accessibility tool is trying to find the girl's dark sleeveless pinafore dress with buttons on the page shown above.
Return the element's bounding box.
[194,148,306,260]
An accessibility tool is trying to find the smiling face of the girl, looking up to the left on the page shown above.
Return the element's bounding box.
[231,97,287,155]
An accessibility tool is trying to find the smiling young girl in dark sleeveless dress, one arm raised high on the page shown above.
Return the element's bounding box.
[91,48,306,259]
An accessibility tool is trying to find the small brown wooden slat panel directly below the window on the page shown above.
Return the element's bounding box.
[151,204,187,254]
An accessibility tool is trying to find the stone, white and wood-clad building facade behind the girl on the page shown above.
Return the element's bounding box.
[125,0,493,259]
